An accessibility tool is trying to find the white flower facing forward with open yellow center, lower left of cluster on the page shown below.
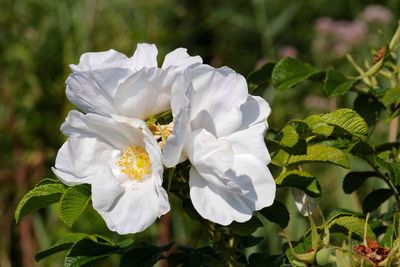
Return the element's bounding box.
[53,111,170,234]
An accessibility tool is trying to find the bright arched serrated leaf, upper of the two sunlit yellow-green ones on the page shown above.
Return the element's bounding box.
[320,108,368,138]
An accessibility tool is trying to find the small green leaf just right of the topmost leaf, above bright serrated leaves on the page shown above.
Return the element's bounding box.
[325,70,358,96]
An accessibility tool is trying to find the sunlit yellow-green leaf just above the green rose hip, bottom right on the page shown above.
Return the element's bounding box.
[328,215,376,240]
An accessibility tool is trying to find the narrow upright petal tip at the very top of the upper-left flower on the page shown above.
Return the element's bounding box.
[132,44,158,70]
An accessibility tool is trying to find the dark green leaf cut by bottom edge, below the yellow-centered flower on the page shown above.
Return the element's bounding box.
[64,236,119,267]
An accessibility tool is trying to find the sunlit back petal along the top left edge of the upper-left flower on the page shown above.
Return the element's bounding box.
[70,49,128,72]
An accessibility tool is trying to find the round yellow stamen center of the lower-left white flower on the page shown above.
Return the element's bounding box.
[116,145,151,181]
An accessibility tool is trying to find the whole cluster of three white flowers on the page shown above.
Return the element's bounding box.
[53,44,275,234]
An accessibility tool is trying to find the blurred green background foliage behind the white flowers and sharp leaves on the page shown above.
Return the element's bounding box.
[0,0,400,267]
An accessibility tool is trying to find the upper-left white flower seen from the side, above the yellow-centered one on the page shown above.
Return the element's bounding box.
[66,44,202,120]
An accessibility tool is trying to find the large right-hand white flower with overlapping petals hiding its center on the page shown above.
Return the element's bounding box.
[164,65,276,225]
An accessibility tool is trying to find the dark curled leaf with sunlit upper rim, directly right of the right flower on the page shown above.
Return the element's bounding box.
[275,170,321,197]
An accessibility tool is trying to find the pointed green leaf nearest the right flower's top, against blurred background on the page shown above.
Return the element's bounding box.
[272,58,320,90]
